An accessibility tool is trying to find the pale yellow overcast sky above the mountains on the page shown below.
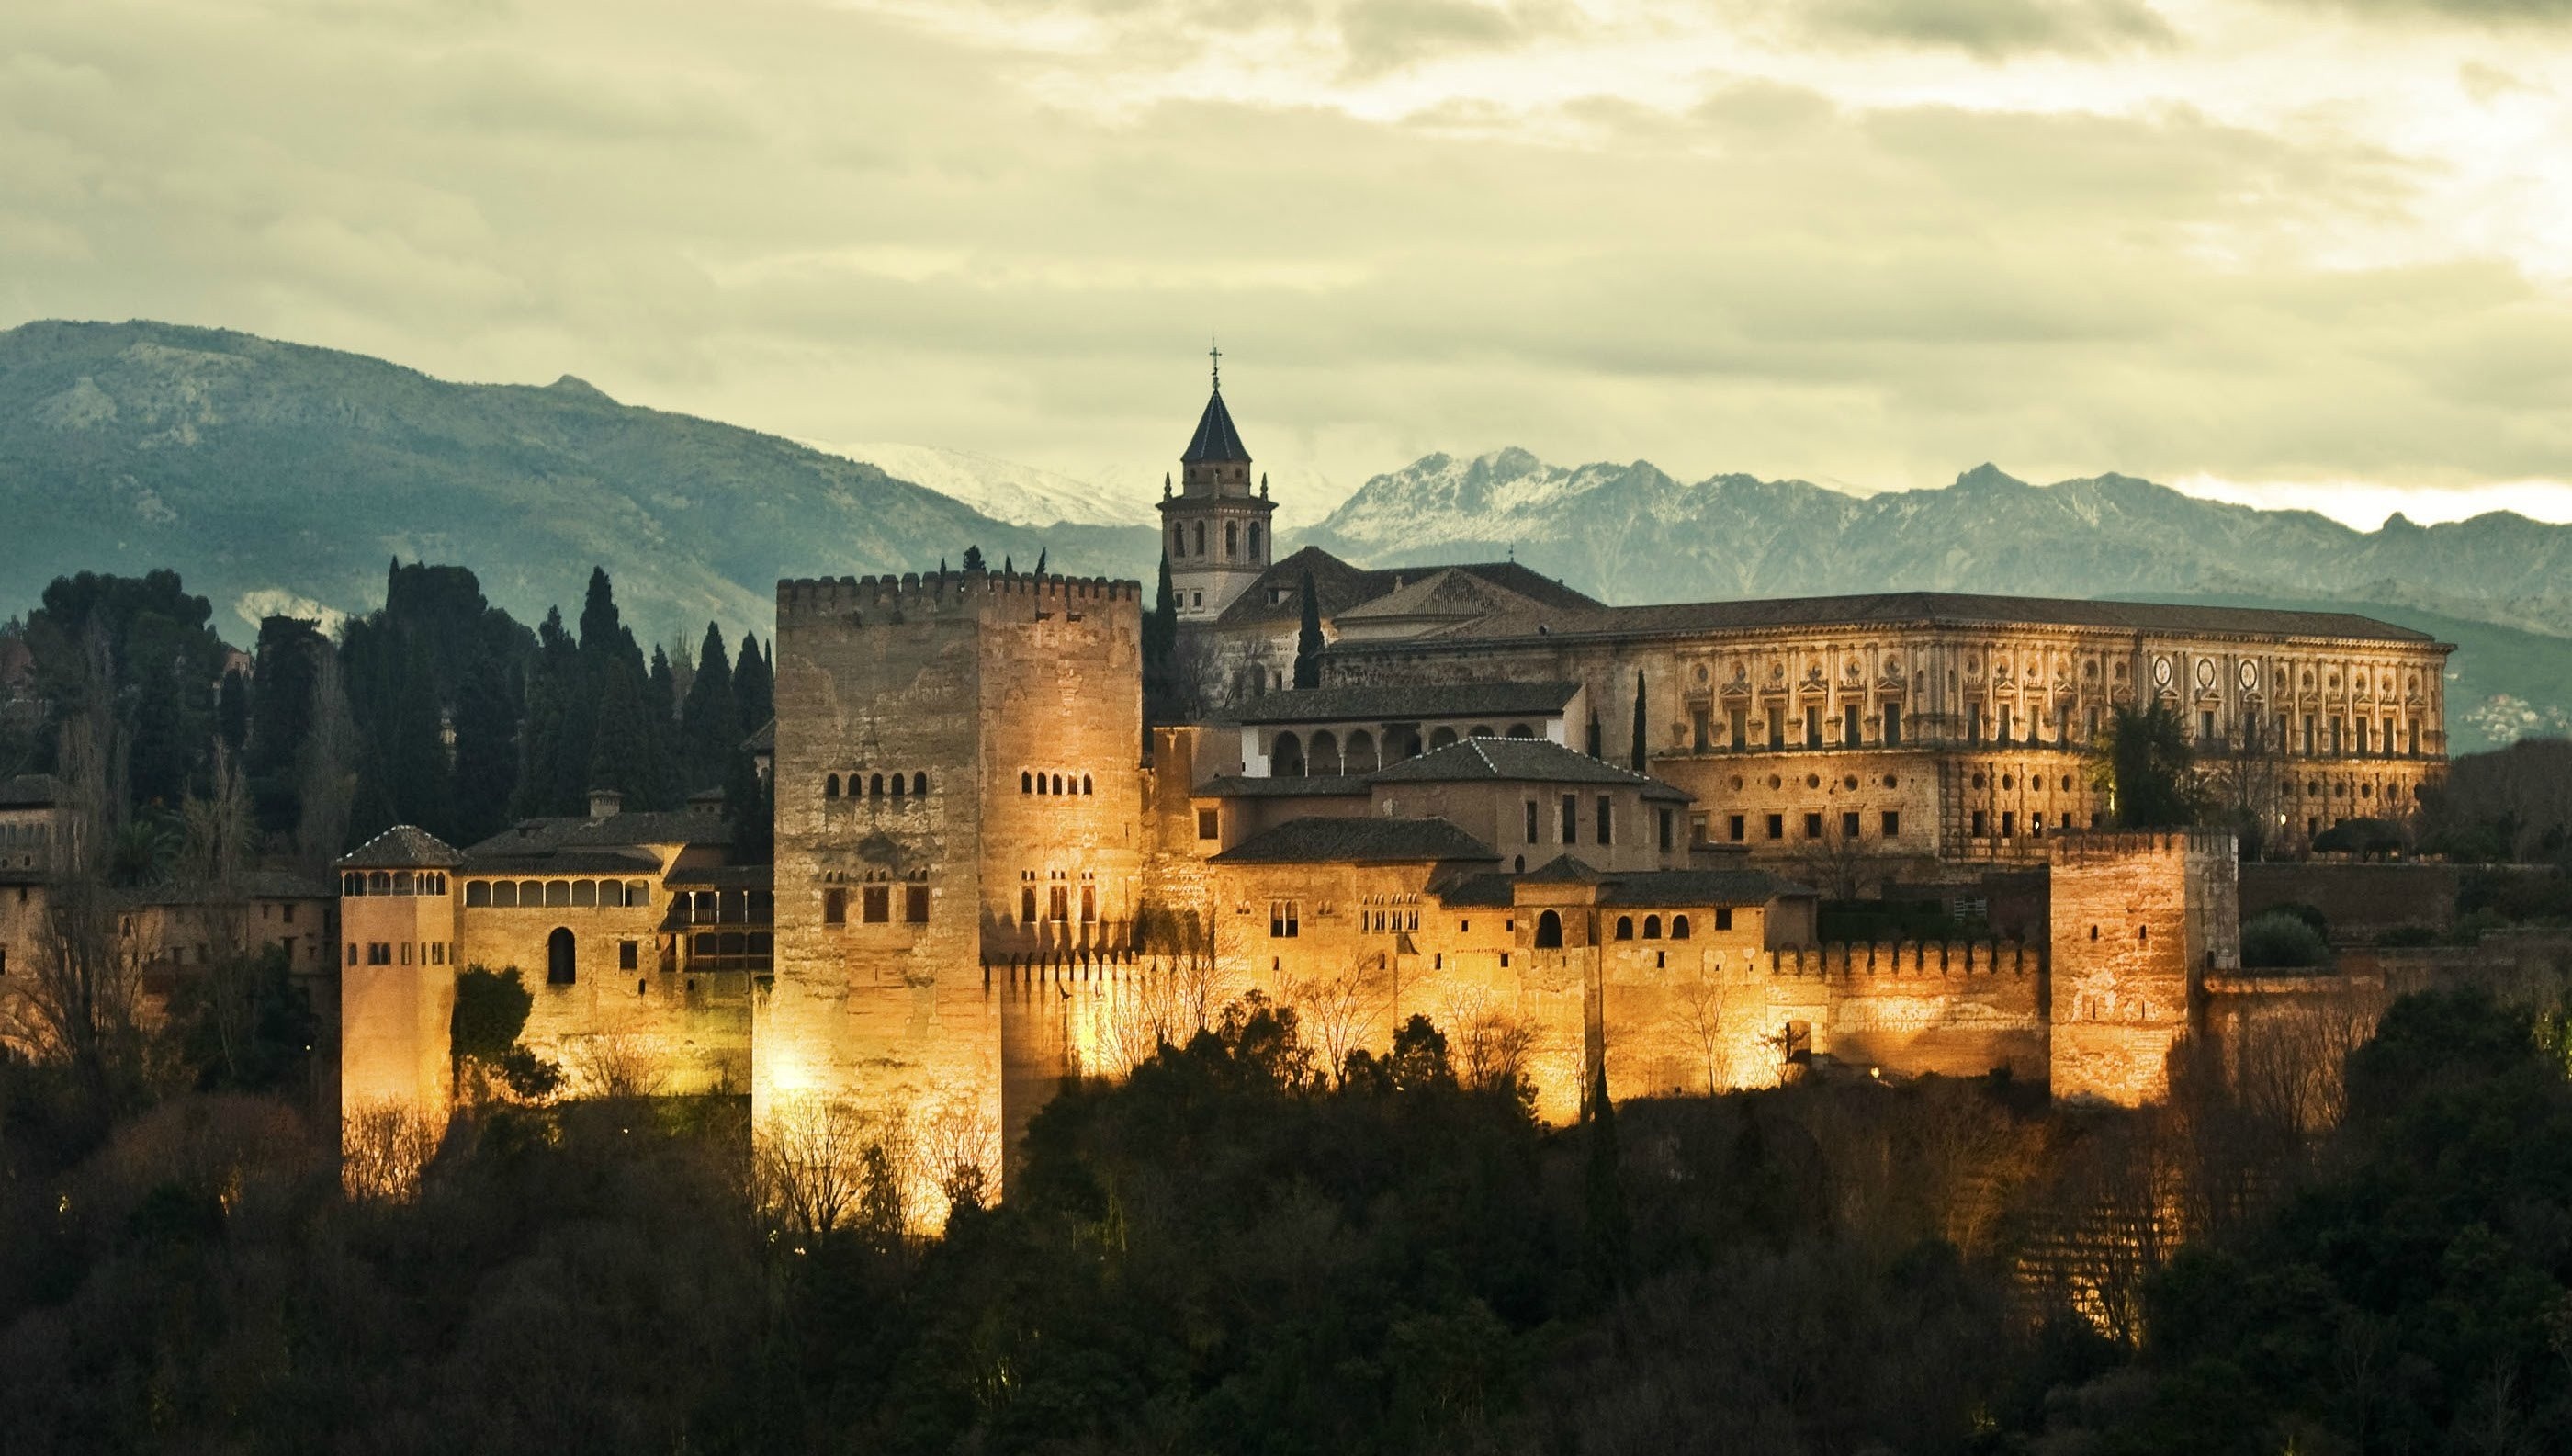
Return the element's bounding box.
[0,0,2572,525]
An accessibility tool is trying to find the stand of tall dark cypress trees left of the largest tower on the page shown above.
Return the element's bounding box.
[0,560,772,883]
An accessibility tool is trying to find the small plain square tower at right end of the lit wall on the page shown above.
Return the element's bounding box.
[2050,829,2243,1106]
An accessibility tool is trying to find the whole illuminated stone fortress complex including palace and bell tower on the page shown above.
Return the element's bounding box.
[340,365,2449,1209]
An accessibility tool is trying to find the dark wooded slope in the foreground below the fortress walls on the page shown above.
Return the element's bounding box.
[0,986,2572,1456]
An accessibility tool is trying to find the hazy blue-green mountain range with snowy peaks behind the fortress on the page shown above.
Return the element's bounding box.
[0,322,2572,746]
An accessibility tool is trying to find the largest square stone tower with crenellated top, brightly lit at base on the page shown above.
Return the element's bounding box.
[751,571,1145,1198]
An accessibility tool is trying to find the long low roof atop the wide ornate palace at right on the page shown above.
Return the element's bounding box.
[1332,592,2433,650]
